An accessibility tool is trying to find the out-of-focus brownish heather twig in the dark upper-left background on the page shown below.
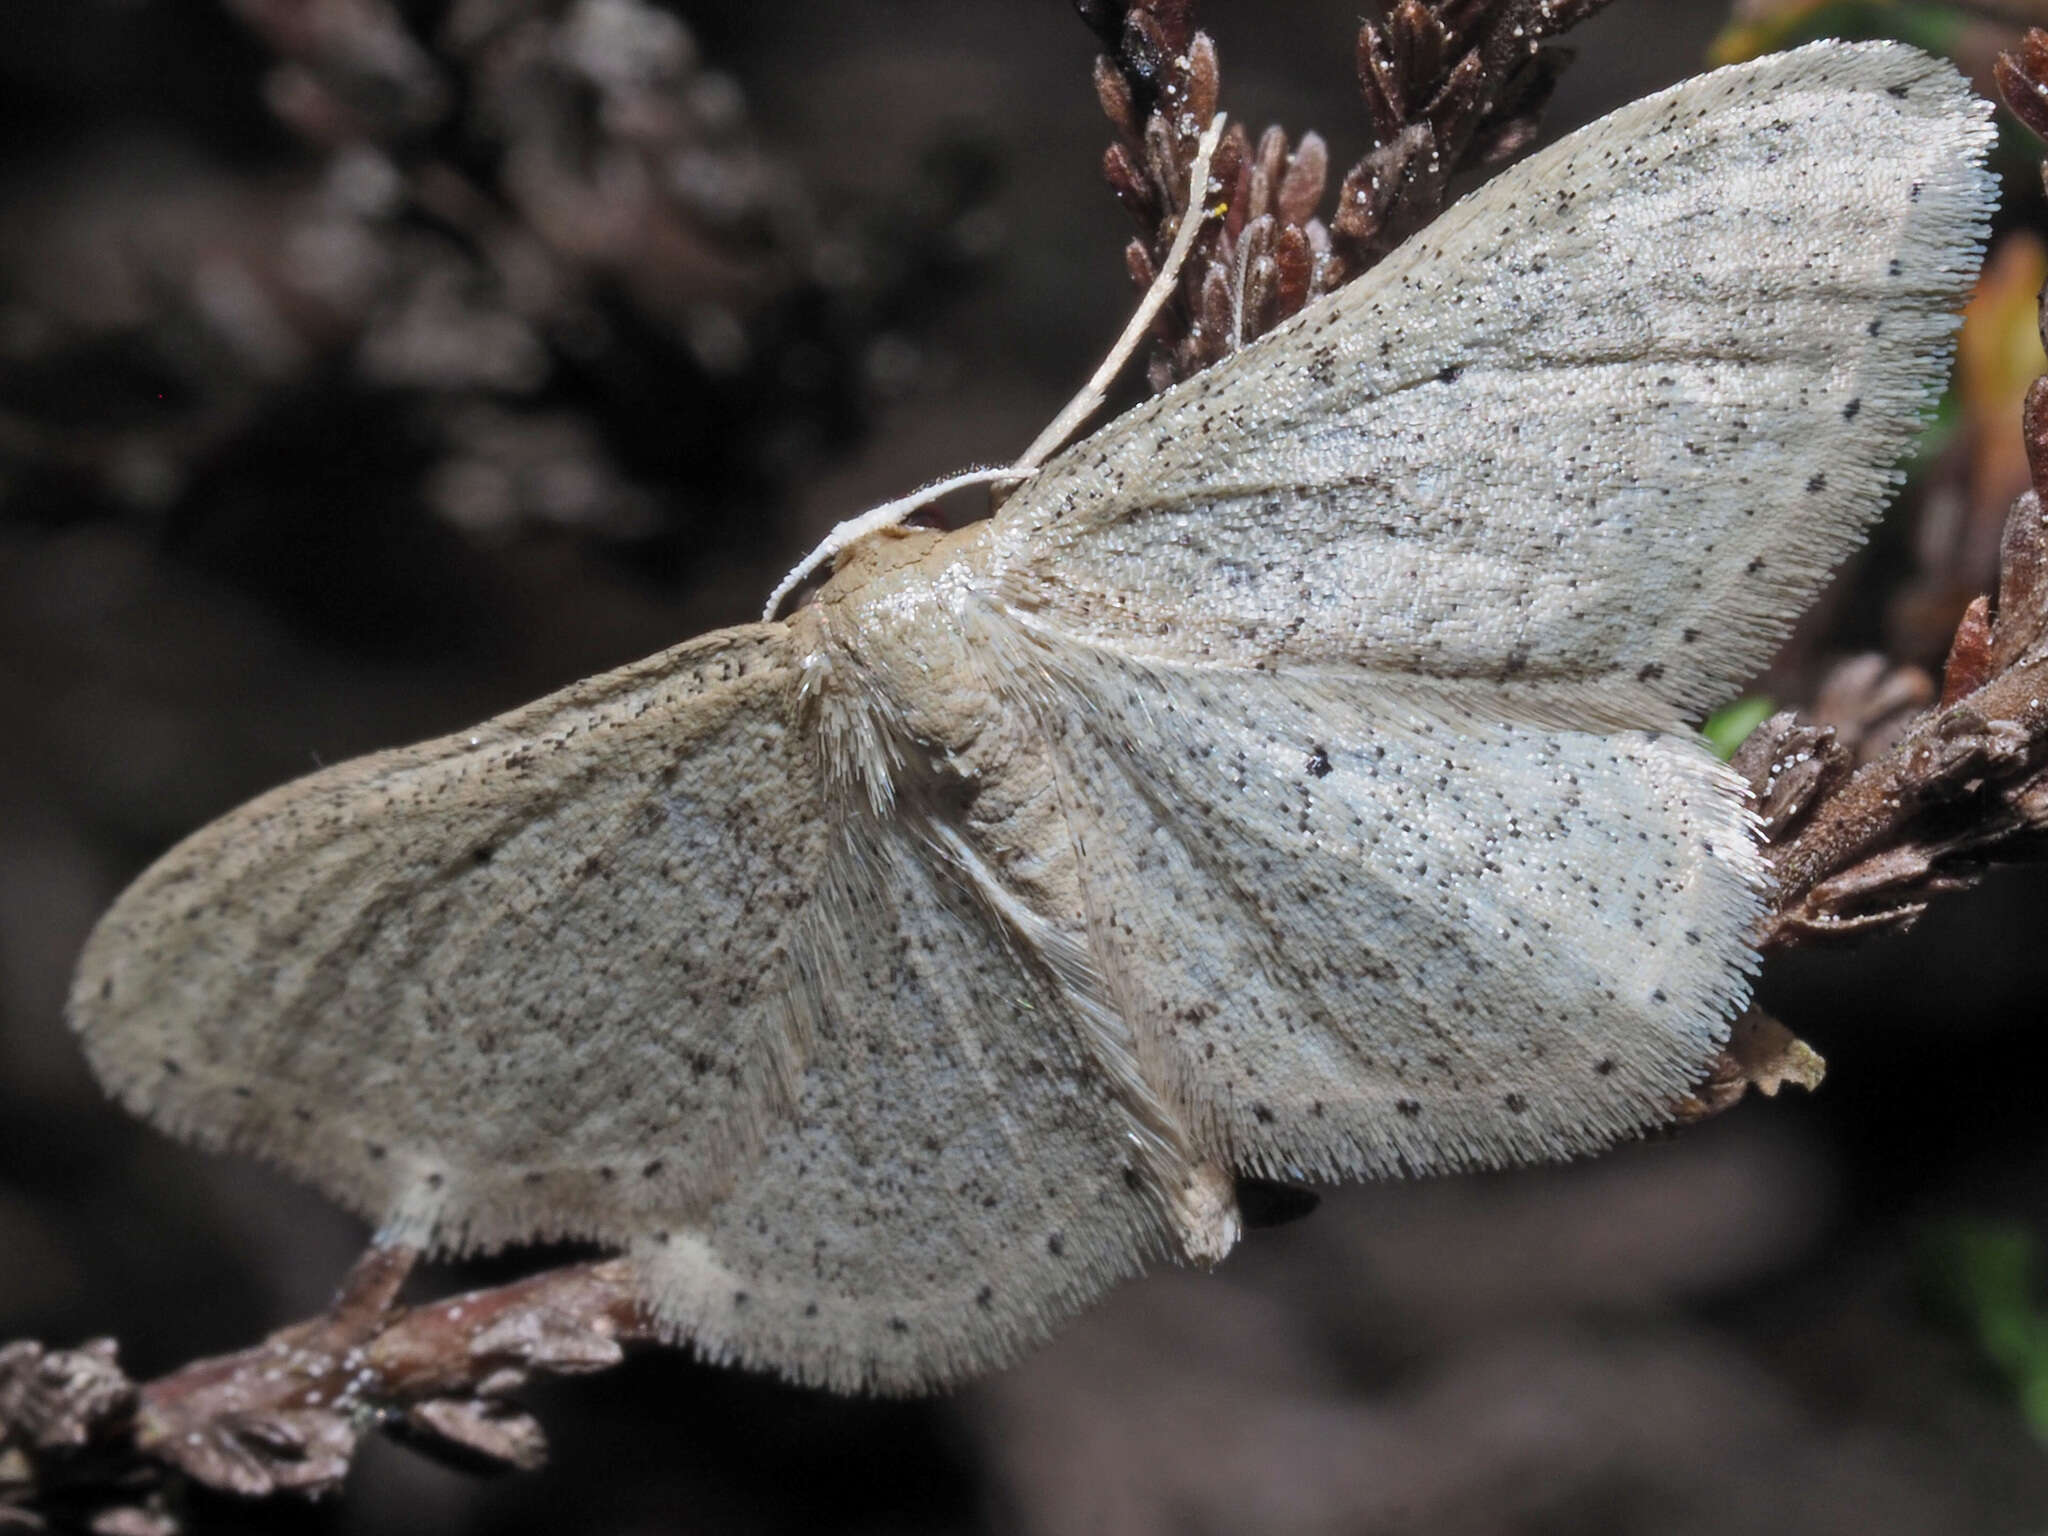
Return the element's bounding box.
[0,0,987,565]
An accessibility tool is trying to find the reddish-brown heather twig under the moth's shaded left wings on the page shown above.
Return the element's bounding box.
[0,1247,649,1532]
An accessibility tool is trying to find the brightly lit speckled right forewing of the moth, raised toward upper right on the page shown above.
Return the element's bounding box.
[987,43,1995,729]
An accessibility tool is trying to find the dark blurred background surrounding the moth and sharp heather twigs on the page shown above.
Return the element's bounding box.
[0,0,2048,1536]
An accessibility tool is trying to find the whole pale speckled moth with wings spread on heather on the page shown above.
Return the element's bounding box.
[70,43,1993,1391]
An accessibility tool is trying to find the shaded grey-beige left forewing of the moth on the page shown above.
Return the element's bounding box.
[70,625,829,1247]
